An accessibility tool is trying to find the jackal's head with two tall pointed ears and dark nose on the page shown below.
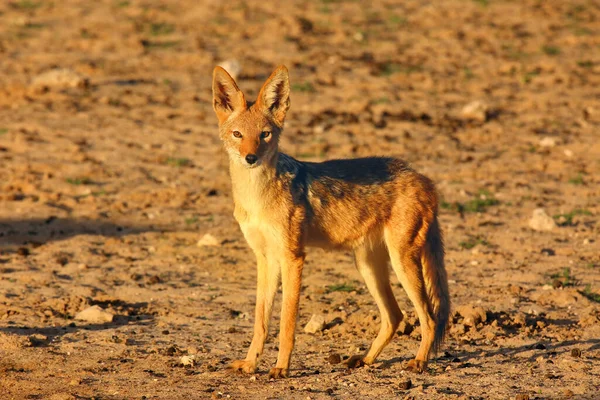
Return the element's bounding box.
[213,65,290,168]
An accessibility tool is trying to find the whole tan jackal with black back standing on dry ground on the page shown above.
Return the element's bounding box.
[213,66,450,378]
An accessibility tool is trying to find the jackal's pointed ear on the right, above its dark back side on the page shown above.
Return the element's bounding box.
[256,65,290,126]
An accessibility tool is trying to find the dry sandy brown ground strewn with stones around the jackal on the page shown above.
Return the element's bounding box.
[0,0,600,400]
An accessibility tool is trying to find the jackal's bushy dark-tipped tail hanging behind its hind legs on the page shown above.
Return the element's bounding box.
[421,216,450,352]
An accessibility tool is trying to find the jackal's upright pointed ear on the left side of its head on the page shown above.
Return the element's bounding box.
[213,67,246,124]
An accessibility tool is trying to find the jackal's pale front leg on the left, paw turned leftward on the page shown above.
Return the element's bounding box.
[231,252,279,374]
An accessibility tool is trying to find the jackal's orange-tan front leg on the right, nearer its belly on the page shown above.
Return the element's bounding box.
[269,252,304,378]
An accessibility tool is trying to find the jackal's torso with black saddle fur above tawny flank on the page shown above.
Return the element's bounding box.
[282,155,437,248]
